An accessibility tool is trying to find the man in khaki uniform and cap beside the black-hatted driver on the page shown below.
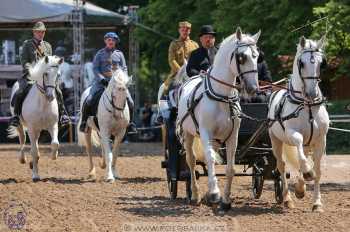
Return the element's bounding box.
[165,21,199,87]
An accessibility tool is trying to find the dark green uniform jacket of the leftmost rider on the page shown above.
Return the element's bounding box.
[20,39,52,74]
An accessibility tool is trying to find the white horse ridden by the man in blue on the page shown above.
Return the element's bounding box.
[77,69,131,182]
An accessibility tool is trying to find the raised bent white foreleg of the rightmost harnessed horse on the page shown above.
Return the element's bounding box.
[286,131,315,181]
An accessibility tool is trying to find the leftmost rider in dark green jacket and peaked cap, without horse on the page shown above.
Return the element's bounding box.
[10,22,69,127]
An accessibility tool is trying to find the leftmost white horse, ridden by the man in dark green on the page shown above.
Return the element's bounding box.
[8,56,63,181]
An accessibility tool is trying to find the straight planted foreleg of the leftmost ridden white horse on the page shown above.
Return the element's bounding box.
[28,128,40,182]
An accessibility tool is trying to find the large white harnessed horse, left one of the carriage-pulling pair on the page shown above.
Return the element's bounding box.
[177,28,260,210]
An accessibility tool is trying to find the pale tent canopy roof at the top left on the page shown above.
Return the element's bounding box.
[0,0,128,25]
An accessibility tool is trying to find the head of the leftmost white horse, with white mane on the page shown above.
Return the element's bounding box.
[29,56,63,101]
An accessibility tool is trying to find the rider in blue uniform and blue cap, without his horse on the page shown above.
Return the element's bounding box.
[79,32,137,133]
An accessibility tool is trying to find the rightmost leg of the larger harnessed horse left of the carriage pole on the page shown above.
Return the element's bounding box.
[220,119,240,211]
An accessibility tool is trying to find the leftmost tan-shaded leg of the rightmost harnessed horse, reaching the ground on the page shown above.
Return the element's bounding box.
[270,132,294,208]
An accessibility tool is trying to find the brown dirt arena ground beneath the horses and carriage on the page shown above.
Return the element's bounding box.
[0,144,350,232]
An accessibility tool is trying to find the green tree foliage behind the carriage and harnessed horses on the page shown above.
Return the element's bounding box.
[92,0,350,105]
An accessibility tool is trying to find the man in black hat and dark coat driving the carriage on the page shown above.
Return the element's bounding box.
[186,25,217,77]
